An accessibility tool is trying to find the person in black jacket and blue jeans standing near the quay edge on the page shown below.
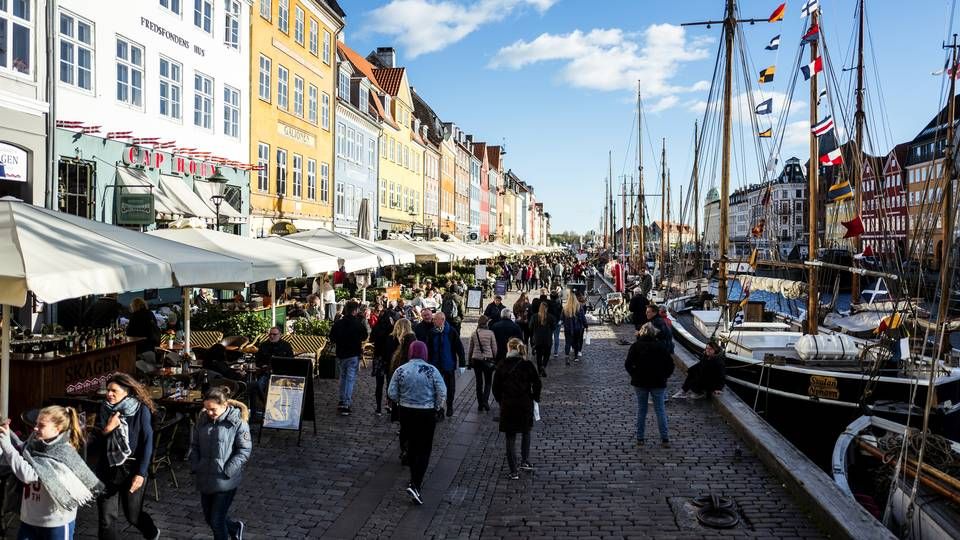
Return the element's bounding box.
[623,323,673,448]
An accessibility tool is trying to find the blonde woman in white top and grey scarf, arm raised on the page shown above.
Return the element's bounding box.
[0,406,103,539]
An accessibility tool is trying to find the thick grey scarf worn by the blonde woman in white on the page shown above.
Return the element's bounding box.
[23,432,104,510]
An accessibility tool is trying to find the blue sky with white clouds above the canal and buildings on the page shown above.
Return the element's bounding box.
[340,0,956,232]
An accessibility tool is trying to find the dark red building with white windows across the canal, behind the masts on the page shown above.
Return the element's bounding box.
[861,143,910,257]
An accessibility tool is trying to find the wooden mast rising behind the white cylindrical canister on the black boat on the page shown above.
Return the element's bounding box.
[806,10,820,335]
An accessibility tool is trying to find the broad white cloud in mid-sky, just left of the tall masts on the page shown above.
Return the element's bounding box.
[490,24,712,110]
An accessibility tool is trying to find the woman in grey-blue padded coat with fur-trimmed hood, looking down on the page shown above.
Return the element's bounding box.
[190,387,253,540]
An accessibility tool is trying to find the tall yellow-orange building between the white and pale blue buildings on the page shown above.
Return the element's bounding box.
[250,0,345,236]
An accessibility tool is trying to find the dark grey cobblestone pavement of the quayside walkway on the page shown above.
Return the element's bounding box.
[15,295,823,539]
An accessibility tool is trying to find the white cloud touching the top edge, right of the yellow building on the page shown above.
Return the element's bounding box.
[366,0,559,58]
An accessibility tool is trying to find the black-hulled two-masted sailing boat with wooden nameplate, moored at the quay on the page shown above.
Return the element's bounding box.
[668,0,960,456]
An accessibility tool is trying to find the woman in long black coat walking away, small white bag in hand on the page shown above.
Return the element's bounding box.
[493,338,541,480]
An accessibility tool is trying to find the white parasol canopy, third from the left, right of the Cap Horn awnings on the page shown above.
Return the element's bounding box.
[147,228,337,281]
